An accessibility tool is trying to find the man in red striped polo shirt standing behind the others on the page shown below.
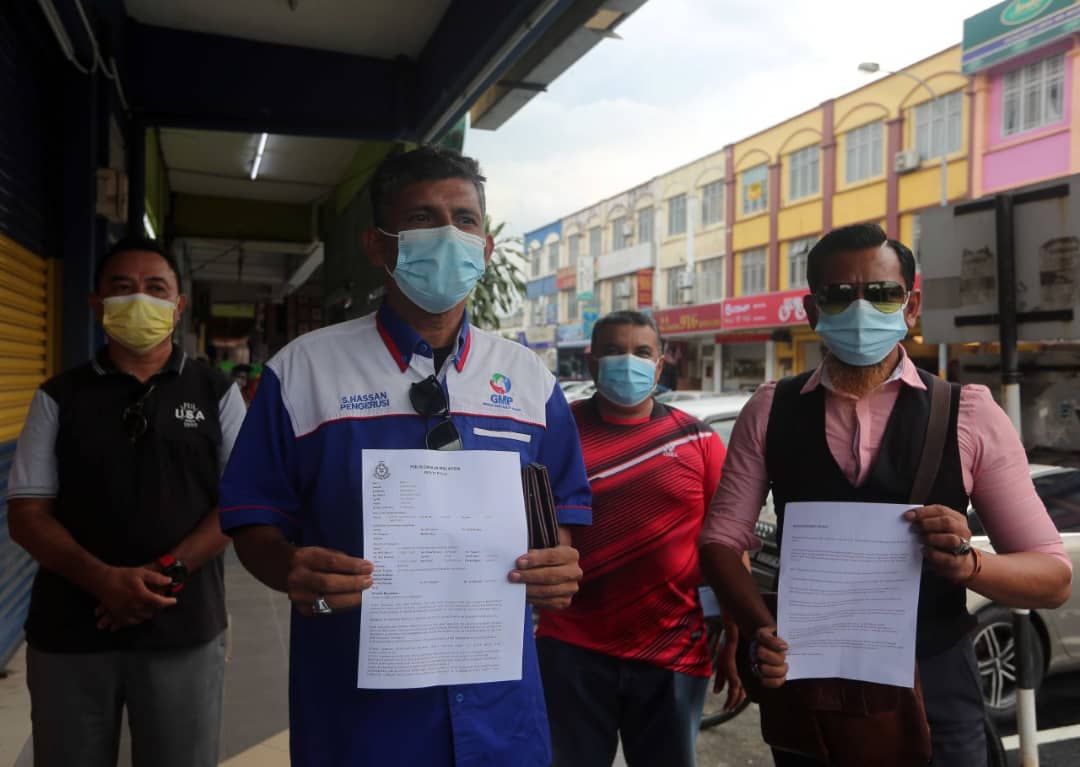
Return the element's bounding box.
[537,311,743,767]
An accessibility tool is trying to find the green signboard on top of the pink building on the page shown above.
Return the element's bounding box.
[960,0,1080,75]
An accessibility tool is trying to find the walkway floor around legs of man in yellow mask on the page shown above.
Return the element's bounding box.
[0,548,289,767]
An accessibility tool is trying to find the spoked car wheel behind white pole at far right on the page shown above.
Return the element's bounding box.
[973,605,1045,724]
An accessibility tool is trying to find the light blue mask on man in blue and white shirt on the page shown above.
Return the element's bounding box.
[379,225,486,314]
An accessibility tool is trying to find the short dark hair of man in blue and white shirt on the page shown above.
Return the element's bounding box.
[372,144,487,227]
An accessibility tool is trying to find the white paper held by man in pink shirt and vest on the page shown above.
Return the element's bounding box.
[777,502,922,687]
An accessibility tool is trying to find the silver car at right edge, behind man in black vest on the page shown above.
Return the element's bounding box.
[968,463,1080,722]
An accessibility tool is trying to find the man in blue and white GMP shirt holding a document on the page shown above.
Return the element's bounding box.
[221,147,592,767]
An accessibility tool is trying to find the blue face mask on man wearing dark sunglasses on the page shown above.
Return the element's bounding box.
[814,298,907,367]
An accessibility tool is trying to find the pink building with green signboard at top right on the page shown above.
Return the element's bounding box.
[962,0,1080,198]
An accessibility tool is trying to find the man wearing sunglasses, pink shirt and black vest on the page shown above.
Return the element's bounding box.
[701,225,1071,767]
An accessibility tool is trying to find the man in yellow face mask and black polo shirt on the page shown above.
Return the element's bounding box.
[8,240,244,767]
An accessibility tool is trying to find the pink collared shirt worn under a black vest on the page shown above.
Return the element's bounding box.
[700,347,1071,569]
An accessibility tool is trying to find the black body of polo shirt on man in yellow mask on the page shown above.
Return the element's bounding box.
[26,348,231,652]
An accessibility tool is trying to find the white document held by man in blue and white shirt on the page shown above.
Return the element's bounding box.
[356,449,528,689]
